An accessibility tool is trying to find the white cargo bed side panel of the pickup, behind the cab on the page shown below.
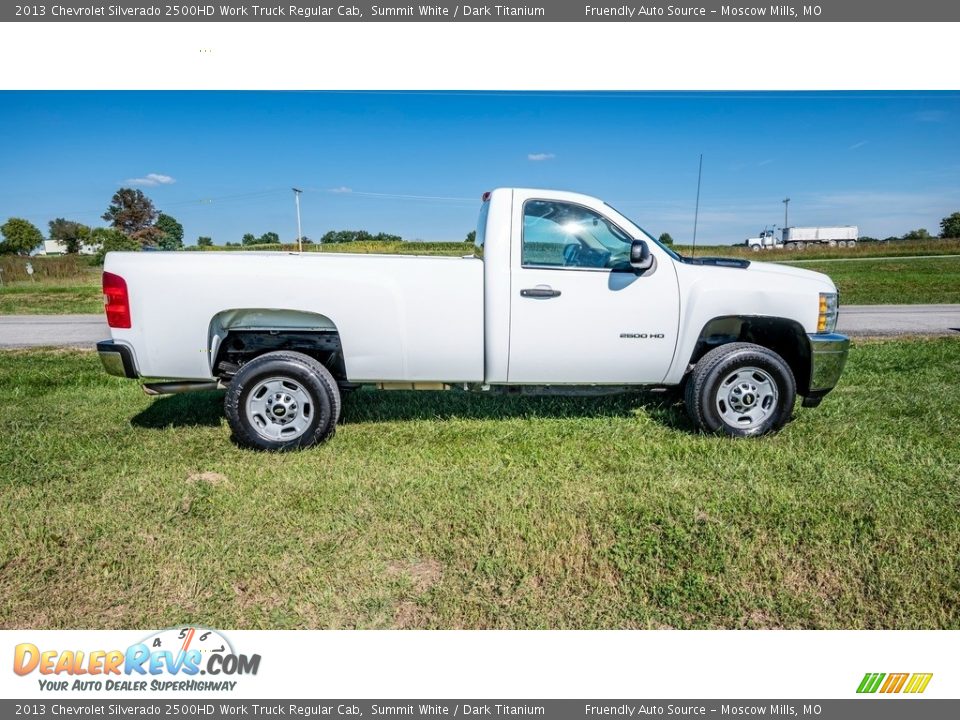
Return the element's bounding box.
[104,252,484,382]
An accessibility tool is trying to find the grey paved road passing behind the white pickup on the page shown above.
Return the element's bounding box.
[0,305,960,348]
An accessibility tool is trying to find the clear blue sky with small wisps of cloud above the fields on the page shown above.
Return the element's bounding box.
[0,91,960,244]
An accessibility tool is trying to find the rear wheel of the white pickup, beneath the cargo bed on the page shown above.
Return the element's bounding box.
[223,350,340,452]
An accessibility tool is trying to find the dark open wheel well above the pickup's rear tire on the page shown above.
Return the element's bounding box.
[213,329,347,385]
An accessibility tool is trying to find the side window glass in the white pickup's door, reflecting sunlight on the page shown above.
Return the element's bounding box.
[521,200,631,269]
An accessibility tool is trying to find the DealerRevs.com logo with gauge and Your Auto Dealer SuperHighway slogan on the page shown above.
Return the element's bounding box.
[13,627,260,692]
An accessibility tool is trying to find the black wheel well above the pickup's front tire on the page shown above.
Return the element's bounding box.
[689,315,810,395]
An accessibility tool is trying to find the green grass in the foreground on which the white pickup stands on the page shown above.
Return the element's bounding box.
[0,339,960,629]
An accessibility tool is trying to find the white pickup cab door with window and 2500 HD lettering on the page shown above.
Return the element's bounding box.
[507,193,679,384]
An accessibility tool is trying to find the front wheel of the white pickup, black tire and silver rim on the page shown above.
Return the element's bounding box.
[684,343,797,437]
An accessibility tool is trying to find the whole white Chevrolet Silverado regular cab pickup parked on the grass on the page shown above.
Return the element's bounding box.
[97,188,849,450]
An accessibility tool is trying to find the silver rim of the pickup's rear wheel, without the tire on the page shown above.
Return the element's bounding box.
[245,377,314,442]
